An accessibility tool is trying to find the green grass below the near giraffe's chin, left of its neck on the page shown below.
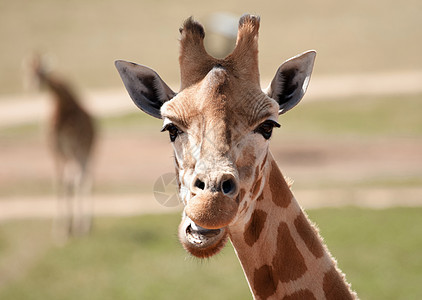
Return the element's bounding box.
[0,215,249,299]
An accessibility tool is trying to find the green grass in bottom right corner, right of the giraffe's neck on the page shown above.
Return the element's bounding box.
[310,208,422,299]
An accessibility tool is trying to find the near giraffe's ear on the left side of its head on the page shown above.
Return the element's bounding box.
[115,60,176,119]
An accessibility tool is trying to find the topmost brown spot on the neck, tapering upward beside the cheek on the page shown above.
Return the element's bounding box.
[269,161,293,208]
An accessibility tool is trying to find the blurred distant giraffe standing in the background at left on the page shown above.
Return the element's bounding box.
[25,55,96,239]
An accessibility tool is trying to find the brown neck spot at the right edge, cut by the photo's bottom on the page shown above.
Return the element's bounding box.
[323,267,354,300]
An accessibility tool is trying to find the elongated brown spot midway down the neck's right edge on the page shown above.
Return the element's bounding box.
[294,212,324,258]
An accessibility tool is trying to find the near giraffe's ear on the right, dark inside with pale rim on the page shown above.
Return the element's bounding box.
[266,51,316,114]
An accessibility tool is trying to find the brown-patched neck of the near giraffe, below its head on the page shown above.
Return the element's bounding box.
[229,154,354,299]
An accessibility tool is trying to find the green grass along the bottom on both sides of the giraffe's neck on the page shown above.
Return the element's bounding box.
[0,208,422,299]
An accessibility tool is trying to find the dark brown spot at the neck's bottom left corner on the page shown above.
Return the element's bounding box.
[253,265,277,299]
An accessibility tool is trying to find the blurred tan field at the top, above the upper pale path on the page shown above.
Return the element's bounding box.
[0,0,422,94]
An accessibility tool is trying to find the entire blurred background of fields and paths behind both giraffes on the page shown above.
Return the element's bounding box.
[0,0,422,299]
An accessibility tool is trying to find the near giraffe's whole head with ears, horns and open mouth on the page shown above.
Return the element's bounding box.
[116,15,315,257]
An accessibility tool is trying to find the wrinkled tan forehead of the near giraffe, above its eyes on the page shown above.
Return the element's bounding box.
[161,68,278,131]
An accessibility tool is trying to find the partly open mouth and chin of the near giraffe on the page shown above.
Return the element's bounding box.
[179,217,227,258]
